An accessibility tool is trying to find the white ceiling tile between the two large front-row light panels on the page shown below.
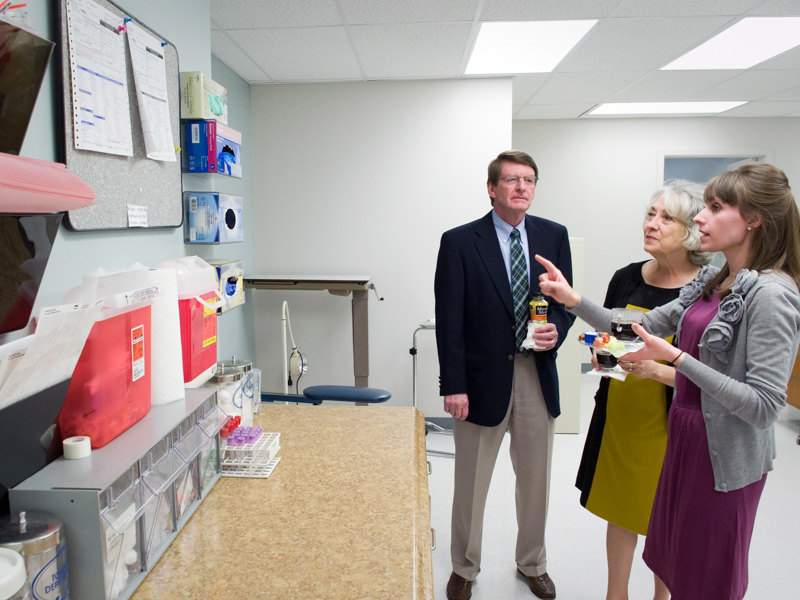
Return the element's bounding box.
[557,17,727,71]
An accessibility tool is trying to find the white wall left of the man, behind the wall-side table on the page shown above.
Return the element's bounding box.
[251,79,511,416]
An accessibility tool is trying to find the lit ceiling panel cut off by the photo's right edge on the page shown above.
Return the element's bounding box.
[661,17,800,71]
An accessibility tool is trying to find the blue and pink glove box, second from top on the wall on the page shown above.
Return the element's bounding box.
[181,121,242,179]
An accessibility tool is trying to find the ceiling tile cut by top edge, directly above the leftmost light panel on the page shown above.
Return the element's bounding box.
[480,0,619,21]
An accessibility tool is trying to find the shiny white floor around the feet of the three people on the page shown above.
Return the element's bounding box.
[427,375,800,600]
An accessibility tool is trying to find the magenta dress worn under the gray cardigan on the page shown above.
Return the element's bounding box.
[644,296,767,600]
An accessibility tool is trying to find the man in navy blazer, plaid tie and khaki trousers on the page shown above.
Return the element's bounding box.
[434,150,574,600]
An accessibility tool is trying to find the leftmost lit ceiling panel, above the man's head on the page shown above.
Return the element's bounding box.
[464,20,597,75]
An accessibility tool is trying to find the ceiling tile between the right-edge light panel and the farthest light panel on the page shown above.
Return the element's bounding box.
[609,71,743,102]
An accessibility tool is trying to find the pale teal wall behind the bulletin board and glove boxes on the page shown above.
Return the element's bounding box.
[21,0,255,366]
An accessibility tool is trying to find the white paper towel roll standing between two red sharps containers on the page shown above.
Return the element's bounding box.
[147,269,186,406]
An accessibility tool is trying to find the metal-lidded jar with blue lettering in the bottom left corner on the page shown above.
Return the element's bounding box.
[0,512,69,600]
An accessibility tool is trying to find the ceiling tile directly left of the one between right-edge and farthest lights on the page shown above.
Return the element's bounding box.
[530,71,646,104]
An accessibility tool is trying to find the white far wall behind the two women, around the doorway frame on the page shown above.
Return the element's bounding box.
[513,118,800,330]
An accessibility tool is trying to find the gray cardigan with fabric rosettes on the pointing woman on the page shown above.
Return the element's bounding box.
[570,267,800,492]
